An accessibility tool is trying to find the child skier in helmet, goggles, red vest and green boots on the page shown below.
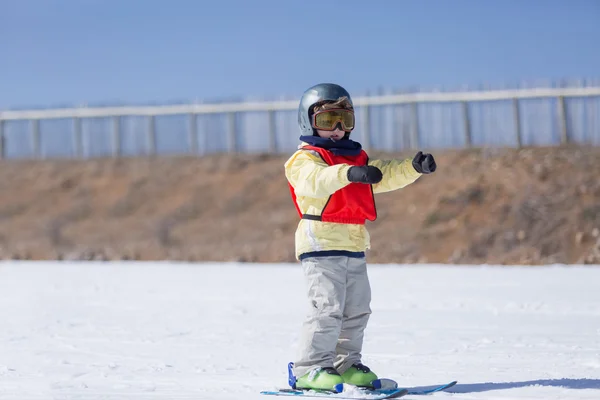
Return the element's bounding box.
[285,83,436,390]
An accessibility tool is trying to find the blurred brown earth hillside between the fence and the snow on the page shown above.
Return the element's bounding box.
[0,148,600,264]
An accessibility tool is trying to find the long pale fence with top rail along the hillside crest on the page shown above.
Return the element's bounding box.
[0,86,600,158]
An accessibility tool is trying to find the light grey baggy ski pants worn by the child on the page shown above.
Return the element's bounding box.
[294,256,371,377]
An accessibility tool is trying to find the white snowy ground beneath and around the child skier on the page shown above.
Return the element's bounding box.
[0,262,600,400]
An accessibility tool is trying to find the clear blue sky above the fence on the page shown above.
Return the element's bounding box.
[0,0,600,109]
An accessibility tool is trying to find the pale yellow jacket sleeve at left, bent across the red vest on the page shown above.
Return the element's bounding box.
[285,150,350,198]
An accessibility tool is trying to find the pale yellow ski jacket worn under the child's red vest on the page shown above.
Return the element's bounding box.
[284,144,421,259]
